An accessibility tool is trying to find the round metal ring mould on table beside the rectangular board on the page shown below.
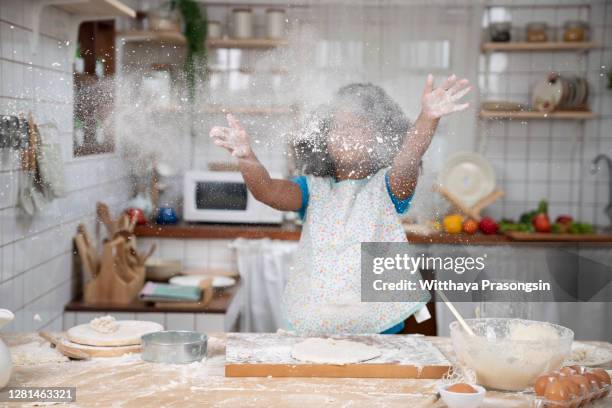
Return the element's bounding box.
[141,330,208,364]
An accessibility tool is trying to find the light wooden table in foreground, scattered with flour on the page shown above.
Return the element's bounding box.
[0,333,612,408]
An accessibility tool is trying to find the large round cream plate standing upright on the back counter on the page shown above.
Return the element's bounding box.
[438,152,495,207]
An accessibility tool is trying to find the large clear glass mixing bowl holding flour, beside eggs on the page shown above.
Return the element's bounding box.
[450,318,574,391]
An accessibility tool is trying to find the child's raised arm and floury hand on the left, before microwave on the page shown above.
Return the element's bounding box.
[210,114,302,211]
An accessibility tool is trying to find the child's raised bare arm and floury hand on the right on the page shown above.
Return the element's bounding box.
[389,74,471,200]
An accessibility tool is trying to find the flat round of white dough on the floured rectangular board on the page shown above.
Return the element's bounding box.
[291,338,381,364]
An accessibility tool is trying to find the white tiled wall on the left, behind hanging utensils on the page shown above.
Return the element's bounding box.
[0,0,129,330]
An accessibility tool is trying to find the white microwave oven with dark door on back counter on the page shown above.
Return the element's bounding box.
[183,171,283,224]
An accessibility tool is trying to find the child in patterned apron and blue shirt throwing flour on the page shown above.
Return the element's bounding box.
[210,75,470,335]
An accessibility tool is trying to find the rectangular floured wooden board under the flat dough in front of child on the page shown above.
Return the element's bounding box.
[225,333,451,379]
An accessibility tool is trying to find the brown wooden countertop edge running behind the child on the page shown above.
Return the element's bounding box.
[134,223,612,247]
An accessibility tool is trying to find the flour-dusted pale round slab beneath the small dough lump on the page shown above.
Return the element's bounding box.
[67,320,164,346]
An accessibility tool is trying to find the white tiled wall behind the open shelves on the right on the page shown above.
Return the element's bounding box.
[479,0,612,225]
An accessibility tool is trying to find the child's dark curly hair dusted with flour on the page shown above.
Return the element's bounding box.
[293,83,410,177]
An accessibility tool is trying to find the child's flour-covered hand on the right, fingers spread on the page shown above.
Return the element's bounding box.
[421,74,472,119]
